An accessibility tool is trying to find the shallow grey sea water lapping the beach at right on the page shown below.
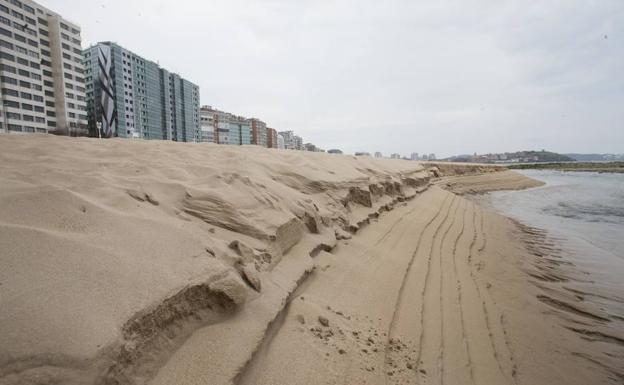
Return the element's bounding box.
[488,170,624,323]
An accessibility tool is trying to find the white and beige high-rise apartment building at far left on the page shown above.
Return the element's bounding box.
[0,0,87,135]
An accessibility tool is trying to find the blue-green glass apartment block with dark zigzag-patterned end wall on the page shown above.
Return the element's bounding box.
[83,42,202,142]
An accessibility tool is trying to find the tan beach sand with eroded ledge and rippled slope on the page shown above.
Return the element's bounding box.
[0,136,624,385]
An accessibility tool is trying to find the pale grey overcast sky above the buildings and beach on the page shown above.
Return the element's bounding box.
[45,0,624,156]
